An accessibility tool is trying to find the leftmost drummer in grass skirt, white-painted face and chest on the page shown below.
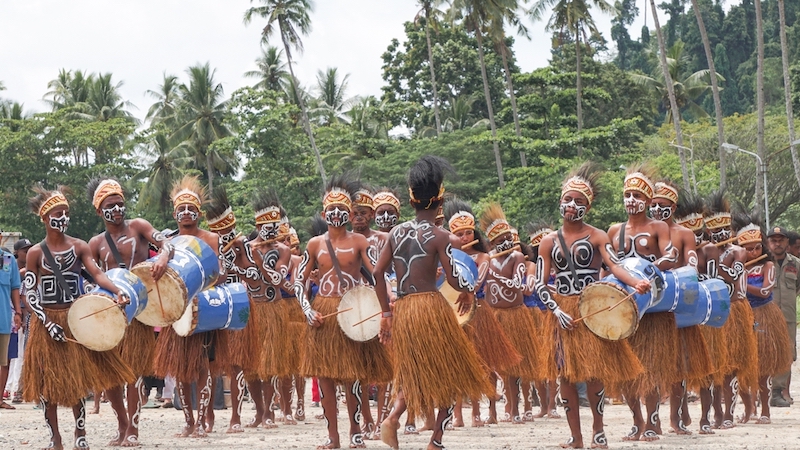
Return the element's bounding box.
[22,186,136,450]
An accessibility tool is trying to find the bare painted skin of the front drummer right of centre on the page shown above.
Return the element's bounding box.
[536,191,650,448]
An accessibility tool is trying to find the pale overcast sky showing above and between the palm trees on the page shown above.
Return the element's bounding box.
[0,0,676,123]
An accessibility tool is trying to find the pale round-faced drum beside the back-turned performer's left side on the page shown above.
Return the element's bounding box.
[336,286,381,342]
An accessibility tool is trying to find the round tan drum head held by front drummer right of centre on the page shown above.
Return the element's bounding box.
[578,281,639,341]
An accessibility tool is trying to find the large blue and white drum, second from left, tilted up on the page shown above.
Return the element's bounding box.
[131,236,219,327]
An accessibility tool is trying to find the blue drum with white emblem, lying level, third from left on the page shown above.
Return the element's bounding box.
[172,283,250,337]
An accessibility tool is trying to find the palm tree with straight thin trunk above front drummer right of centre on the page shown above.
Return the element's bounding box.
[528,0,615,141]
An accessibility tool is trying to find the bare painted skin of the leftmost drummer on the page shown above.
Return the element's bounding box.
[25,206,128,450]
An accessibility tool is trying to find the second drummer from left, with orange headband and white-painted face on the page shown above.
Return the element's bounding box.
[87,178,175,447]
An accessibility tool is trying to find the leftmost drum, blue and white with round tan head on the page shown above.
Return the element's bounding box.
[67,269,147,352]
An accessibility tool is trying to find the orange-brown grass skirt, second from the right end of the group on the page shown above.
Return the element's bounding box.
[722,300,758,390]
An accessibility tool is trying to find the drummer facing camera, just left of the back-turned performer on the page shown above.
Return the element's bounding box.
[294,176,392,448]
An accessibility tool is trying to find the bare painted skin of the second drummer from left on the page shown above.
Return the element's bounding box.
[89,194,173,447]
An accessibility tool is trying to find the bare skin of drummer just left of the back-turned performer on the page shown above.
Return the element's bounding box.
[297,205,373,448]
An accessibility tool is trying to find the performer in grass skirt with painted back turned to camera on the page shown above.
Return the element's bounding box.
[374,156,494,450]
